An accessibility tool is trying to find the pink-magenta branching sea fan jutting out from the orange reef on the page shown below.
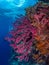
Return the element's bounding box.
[6,17,36,61]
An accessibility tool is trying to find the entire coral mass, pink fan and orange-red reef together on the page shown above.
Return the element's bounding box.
[6,2,49,65]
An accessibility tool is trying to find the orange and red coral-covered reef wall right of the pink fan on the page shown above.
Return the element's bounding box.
[26,2,49,62]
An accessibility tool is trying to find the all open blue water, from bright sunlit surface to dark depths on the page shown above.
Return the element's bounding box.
[0,0,38,65]
